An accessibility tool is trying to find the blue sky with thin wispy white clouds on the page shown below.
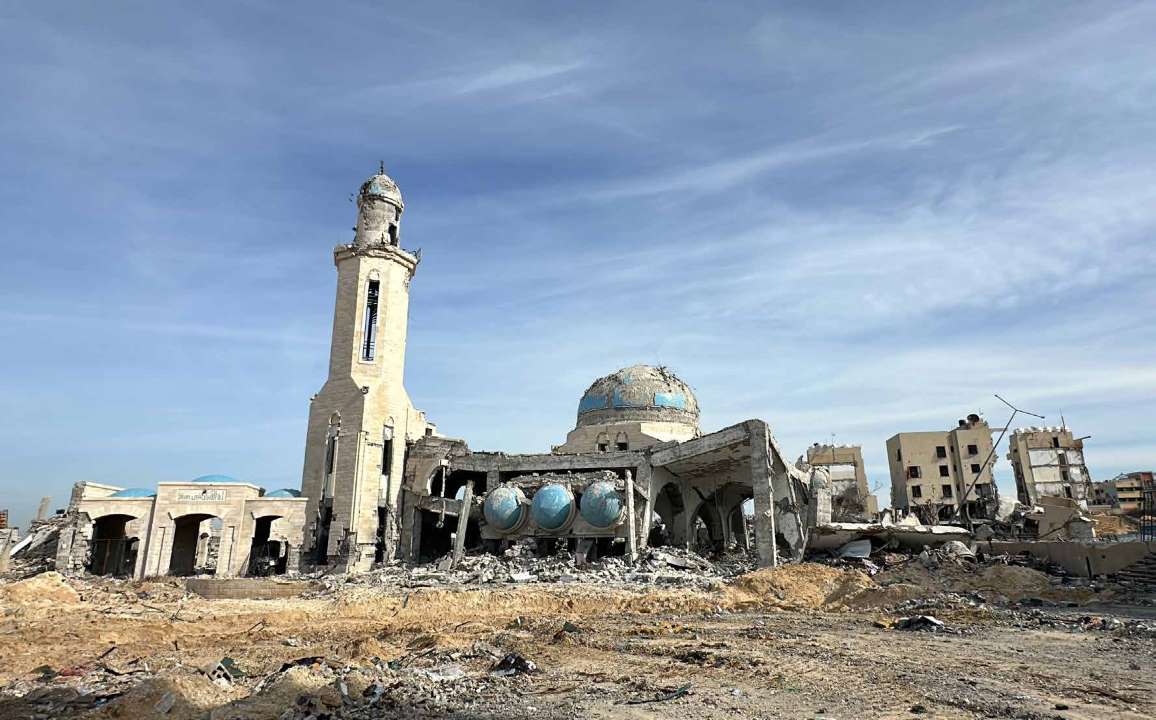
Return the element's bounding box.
[0,0,1156,527]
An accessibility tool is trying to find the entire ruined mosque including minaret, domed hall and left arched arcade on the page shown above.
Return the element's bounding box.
[49,171,829,578]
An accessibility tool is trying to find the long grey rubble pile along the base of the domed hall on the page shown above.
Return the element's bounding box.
[317,544,755,589]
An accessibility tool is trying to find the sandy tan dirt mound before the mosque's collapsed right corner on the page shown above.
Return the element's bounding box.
[728,563,877,610]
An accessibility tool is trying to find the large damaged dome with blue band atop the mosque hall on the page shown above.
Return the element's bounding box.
[578,365,698,428]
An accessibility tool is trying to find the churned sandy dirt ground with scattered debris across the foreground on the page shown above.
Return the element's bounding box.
[0,564,1156,720]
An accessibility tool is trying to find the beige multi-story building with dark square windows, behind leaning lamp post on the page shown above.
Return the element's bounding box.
[887,414,999,522]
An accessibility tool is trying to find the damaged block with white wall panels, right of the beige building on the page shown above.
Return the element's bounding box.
[1008,426,1091,510]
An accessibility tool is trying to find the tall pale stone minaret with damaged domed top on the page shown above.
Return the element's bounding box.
[301,168,428,572]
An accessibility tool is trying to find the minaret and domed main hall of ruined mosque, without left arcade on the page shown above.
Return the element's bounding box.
[302,173,809,571]
